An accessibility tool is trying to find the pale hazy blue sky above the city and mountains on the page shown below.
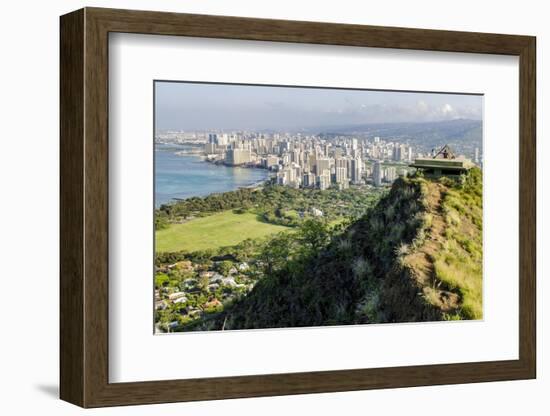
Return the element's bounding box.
[155,82,483,131]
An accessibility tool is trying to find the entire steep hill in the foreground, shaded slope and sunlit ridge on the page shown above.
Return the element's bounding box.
[190,169,482,329]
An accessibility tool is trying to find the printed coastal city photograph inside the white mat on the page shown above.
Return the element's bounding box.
[153,80,484,334]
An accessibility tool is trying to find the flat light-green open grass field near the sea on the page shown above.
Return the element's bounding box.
[155,211,290,252]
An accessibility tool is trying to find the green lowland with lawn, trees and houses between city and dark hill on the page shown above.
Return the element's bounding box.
[155,184,384,331]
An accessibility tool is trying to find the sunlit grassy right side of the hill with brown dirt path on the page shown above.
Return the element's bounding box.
[382,169,482,322]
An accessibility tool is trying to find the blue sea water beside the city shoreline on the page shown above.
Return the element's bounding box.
[155,145,268,207]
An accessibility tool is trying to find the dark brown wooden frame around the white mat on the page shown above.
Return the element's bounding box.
[60,8,536,407]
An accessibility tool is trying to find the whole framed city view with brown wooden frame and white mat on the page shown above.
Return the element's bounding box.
[60,8,536,407]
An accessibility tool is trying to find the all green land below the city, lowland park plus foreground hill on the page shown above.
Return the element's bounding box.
[155,169,482,331]
